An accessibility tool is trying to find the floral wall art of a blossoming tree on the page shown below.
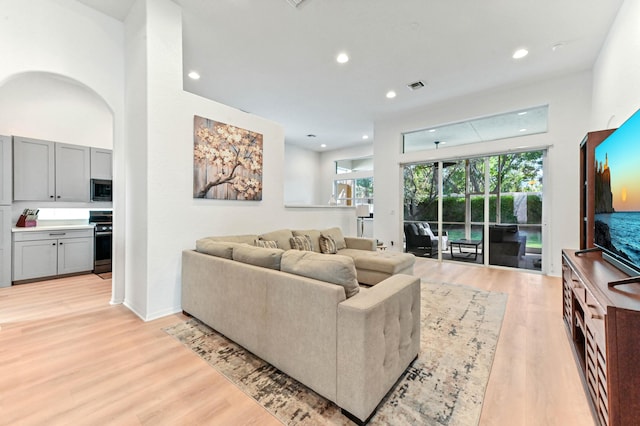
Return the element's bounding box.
[193,115,262,201]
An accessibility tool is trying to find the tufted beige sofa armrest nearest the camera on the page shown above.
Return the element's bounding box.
[336,274,420,420]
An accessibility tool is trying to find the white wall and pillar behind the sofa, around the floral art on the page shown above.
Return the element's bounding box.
[125,0,356,319]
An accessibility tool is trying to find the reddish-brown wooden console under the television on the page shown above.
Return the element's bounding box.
[562,250,640,425]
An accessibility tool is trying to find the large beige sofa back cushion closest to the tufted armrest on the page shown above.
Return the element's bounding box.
[280,250,360,298]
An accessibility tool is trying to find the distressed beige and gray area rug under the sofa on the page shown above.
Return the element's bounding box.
[165,282,507,426]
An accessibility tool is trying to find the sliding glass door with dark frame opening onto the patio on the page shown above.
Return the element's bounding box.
[404,151,545,270]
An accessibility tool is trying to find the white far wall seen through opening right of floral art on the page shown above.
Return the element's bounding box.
[284,144,320,205]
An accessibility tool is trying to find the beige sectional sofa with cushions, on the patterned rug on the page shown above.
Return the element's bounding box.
[182,228,420,422]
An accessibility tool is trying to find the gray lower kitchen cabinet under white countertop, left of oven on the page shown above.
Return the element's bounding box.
[13,228,93,281]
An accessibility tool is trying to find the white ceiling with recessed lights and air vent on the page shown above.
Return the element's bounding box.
[80,0,623,151]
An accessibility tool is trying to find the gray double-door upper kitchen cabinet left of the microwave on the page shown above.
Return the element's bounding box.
[13,136,91,202]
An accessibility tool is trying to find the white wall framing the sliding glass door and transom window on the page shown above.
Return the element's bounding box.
[374,72,591,275]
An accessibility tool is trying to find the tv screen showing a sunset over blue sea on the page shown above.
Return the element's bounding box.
[594,110,640,275]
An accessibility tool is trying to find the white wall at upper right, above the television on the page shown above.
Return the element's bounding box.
[591,0,640,130]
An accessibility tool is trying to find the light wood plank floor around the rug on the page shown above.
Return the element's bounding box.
[0,259,594,426]
